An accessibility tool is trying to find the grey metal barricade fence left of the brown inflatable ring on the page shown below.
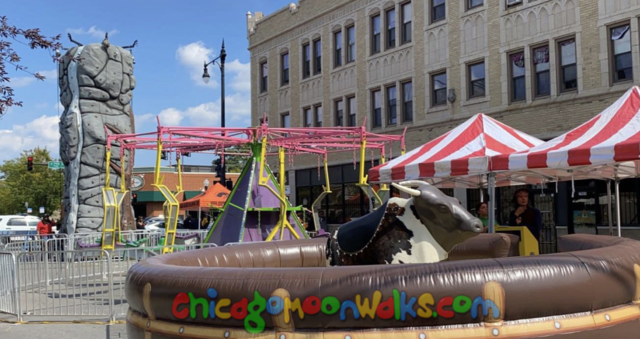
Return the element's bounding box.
[0,244,216,321]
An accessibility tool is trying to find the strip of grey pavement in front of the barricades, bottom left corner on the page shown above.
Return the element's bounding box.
[0,323,127,339]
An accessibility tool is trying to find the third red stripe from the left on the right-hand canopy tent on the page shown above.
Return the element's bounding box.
[567,91,640,166]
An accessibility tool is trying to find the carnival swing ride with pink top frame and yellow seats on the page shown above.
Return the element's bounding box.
[102,116,406,253]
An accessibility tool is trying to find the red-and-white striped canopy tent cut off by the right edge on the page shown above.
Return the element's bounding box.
[491,86,640,181]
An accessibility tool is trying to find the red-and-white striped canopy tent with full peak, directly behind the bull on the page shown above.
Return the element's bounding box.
[369,113,543,188]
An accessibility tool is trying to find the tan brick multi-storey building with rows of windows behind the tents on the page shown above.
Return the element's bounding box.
[247,0,640,244]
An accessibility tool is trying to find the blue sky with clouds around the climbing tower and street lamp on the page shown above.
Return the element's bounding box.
[0,0,291,167]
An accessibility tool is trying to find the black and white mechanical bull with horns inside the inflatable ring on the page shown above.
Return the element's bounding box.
[327,181,482,266]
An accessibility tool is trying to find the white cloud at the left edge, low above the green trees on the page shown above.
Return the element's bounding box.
[0,115,60,160]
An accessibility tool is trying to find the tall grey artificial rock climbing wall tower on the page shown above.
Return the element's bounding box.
[59,39,136,234]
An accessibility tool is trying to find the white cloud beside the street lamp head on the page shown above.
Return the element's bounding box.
[176,41,220,88]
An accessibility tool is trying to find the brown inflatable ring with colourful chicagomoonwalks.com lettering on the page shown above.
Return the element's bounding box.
[126,235,640,339]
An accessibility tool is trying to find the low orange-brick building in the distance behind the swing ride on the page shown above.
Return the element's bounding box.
[131,165,239,218]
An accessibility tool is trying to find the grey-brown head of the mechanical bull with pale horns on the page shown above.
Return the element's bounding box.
[392,180,483,252]
